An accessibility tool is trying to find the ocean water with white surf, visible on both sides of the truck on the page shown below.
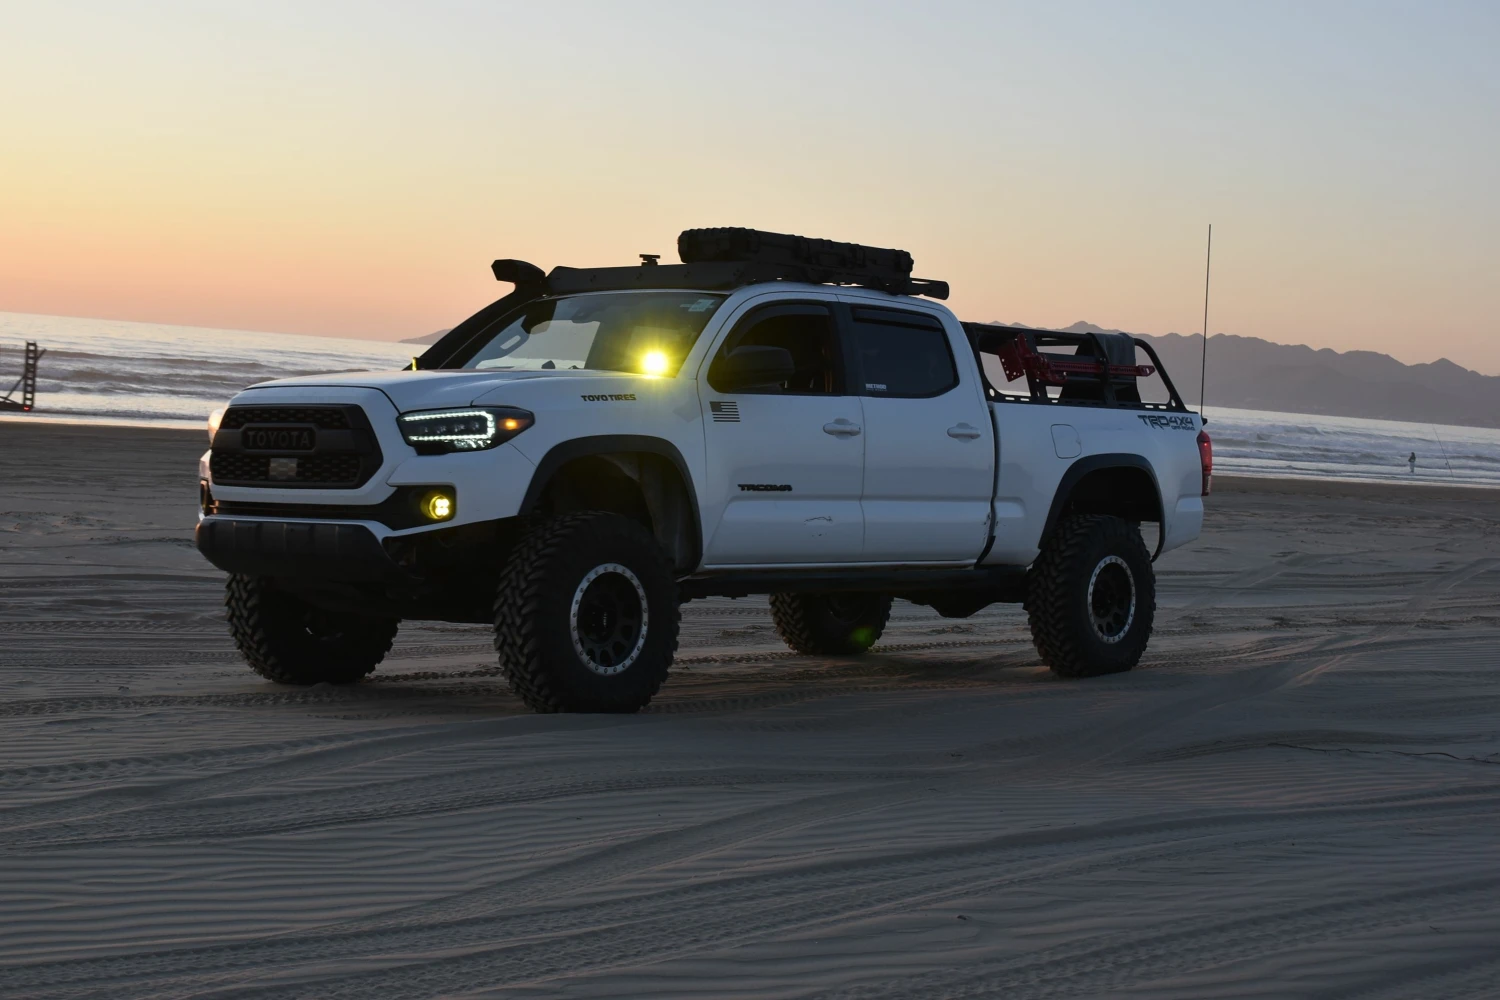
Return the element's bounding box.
[0,313,1500,486]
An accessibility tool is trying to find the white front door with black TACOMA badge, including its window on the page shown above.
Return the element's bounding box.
[699,303,864,567]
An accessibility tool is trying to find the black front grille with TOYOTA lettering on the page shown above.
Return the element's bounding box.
[209,406,381,489]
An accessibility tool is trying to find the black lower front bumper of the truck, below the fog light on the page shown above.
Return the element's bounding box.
[194,517,407,583]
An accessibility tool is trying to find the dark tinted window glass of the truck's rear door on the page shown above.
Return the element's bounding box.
[851,306,959,399]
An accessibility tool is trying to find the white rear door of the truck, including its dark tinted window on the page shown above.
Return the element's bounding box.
[848,303,995,562]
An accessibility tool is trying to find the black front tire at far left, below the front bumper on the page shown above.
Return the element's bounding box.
[224,573,401,685]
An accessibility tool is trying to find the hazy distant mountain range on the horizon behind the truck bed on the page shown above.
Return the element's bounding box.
[1010,322,1500,427]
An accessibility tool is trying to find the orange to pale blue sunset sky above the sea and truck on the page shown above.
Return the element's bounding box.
[0,0,1500,373]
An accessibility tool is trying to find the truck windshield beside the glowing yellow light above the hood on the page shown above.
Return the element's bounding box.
[464,291,725,375]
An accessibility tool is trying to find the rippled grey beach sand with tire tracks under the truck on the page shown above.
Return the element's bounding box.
[0,423,1500,1000]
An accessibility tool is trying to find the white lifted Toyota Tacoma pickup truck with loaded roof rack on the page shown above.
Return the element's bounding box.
[197,229,1211,712]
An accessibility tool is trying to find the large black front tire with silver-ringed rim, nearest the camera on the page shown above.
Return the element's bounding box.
[495,511,681,712]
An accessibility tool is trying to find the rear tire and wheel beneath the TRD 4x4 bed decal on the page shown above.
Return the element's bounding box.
[1026,514,1157,678]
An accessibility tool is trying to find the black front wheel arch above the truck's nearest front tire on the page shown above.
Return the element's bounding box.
[521,435,704,573]
